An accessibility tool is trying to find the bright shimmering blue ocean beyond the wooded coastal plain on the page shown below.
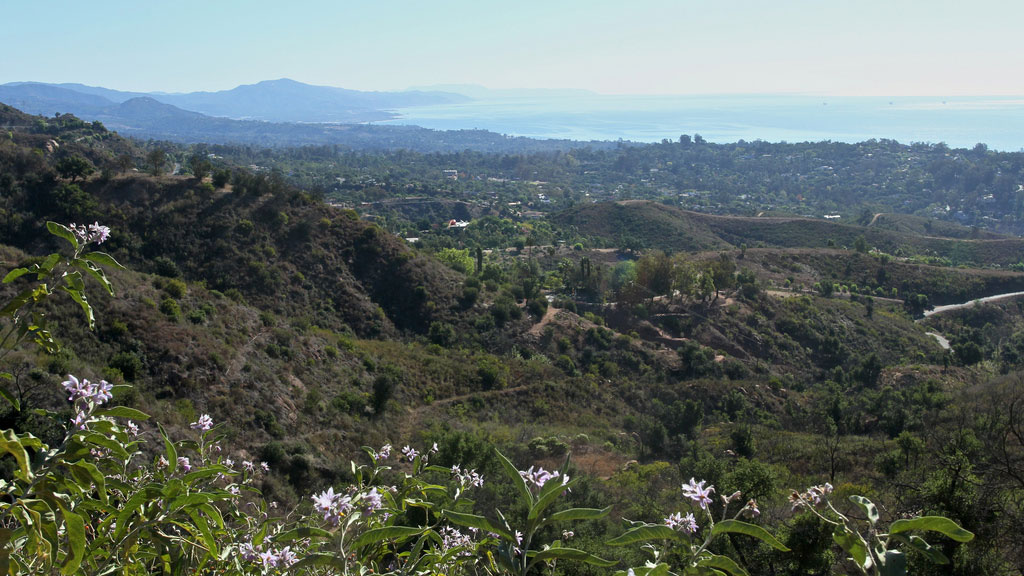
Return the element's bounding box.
[382,94,1024,152]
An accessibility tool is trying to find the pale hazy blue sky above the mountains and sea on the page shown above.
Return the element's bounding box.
[8,0,1024,95]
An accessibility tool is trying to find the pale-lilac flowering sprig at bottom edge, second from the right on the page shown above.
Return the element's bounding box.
[607,478,788,576]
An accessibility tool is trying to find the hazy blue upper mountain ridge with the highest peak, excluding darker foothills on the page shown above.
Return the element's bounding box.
[0,79,470,123]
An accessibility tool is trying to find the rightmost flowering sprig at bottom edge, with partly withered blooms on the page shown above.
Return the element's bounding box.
[790,483,974,576]
